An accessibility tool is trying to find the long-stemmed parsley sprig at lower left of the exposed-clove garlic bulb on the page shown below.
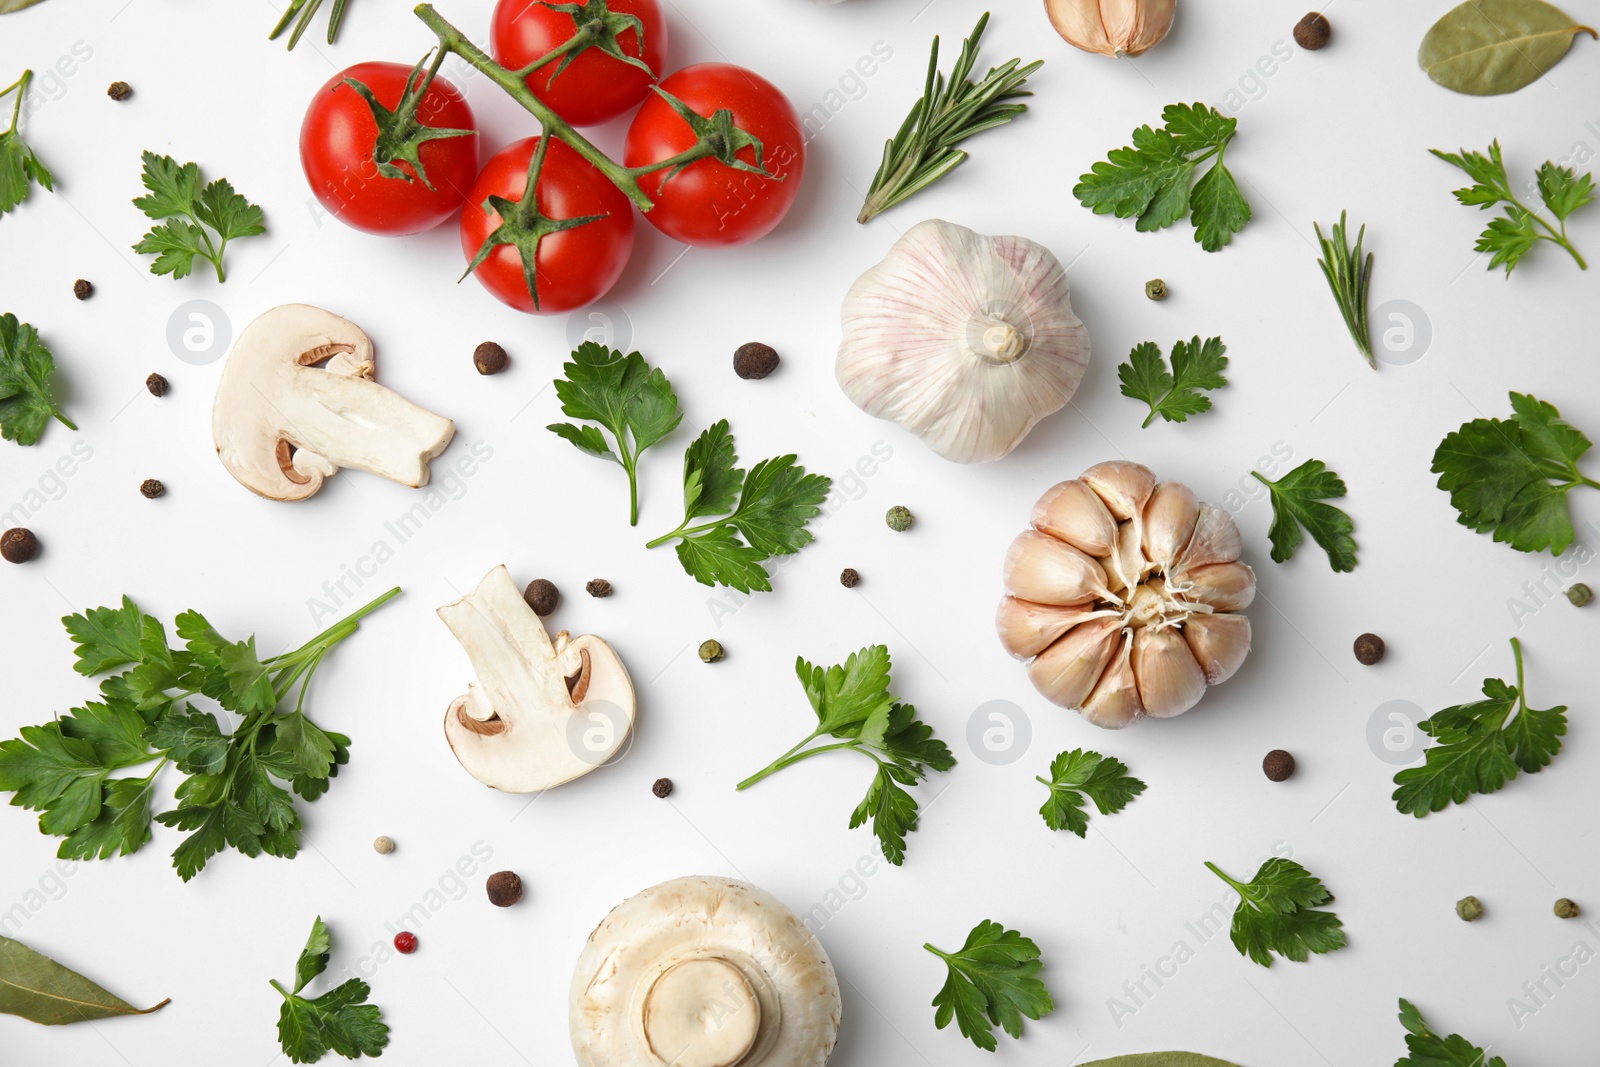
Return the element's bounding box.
[738,645,955,867]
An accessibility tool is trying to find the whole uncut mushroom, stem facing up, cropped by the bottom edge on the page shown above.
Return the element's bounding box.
[570,877,842,1067]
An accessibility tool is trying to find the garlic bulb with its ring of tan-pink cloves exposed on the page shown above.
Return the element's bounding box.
[995,461,1256,729]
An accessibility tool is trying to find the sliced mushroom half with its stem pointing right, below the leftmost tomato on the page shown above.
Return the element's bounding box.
[211,304,456,501]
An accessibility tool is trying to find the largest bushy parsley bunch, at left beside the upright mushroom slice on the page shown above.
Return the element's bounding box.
[0,589,400,881]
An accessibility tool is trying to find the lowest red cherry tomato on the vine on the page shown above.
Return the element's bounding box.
[461,138,634,315]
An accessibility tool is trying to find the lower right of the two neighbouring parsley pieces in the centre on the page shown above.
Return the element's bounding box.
[645,419,834,592]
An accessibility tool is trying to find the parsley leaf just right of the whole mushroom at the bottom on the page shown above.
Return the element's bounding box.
[923,920,1056,1053]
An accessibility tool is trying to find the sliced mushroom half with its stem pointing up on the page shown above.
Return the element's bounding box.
[438,566,635,793]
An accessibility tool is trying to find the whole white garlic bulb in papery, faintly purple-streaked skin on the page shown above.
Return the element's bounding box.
[835,219,1090,462]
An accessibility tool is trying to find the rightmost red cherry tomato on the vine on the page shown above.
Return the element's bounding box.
[622,62,805,245]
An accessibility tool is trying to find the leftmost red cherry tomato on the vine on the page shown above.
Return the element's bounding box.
[301,62,478,234]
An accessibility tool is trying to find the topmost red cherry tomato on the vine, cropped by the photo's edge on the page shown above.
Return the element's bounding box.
[490,0,667,126]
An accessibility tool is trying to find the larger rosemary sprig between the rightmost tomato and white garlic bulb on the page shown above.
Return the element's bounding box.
[856,11,1045,222]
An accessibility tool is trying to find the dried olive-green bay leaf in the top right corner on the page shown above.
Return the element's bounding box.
[1416,0,1600,96]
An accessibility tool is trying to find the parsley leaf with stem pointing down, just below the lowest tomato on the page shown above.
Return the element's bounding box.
[546,341,683,526]
